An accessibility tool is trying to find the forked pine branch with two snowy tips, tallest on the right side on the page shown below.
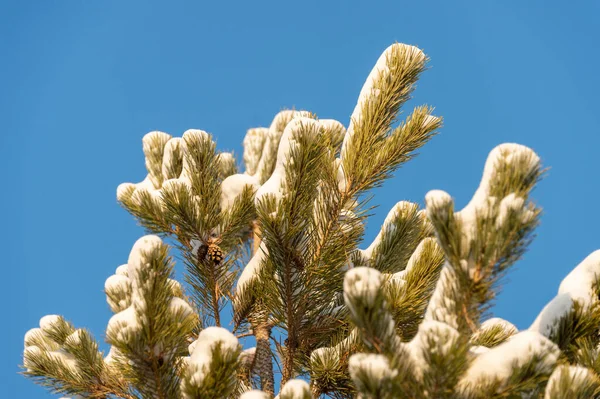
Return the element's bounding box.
[426,144,542,334]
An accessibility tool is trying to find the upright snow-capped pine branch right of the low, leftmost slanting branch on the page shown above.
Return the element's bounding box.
[106,236,197,398]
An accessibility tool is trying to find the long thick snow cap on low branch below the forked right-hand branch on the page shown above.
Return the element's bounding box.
[461,331,560,384]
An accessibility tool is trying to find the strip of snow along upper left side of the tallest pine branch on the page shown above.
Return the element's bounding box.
[341,43,425,158]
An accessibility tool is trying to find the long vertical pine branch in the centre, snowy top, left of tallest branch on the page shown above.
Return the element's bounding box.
[252,119,327,383]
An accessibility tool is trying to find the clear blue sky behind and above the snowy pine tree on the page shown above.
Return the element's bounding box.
[0,0,600,399]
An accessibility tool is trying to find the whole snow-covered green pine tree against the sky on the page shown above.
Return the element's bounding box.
[23,44,600,399]
